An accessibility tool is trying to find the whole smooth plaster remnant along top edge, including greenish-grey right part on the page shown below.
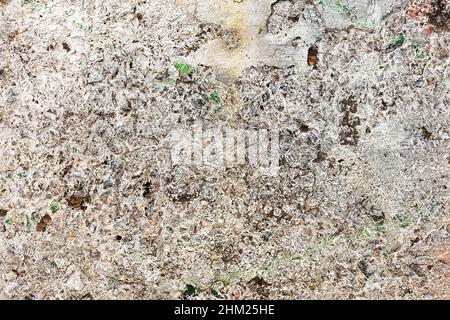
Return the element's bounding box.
[183,0,404,84]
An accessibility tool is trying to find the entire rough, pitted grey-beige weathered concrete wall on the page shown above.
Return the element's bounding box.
[0,0,450,299]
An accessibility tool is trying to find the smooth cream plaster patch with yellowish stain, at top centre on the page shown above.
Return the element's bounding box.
[181,0,319,84]
